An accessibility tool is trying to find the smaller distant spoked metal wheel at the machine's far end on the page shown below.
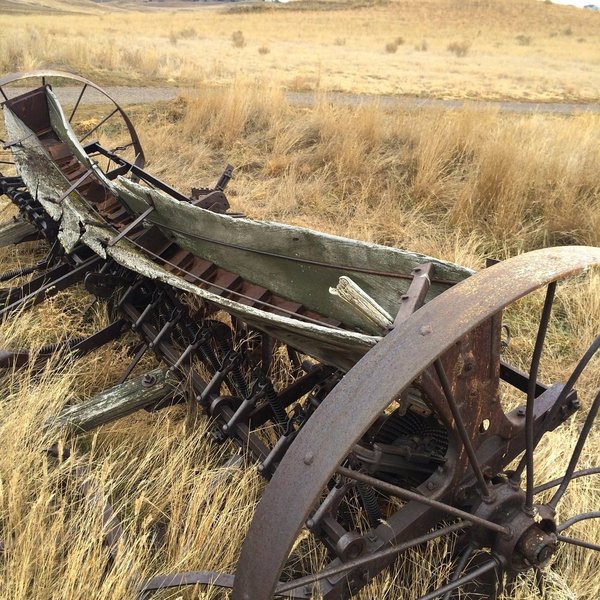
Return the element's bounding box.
[0,70,145,173]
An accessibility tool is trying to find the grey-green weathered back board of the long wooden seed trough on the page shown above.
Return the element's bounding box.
[119,178,472,333]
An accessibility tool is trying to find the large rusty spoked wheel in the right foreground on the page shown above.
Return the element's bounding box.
[232,247,600,600]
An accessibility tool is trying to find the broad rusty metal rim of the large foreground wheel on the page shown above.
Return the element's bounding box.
[232,247,600,600]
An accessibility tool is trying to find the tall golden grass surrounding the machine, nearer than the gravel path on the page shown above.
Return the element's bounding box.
[0,79,600,600]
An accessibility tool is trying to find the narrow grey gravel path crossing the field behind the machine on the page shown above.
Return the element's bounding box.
[5,86,600,115]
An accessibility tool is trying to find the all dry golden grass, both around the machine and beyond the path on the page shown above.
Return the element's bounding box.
[0,0,600,600]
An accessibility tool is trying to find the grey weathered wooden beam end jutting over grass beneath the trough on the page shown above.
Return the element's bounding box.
[47,368,176,432]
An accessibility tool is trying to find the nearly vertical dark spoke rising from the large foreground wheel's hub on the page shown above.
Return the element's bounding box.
[525,281,556,512]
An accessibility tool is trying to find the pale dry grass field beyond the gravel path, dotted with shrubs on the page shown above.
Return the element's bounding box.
[0,0,600,101]
